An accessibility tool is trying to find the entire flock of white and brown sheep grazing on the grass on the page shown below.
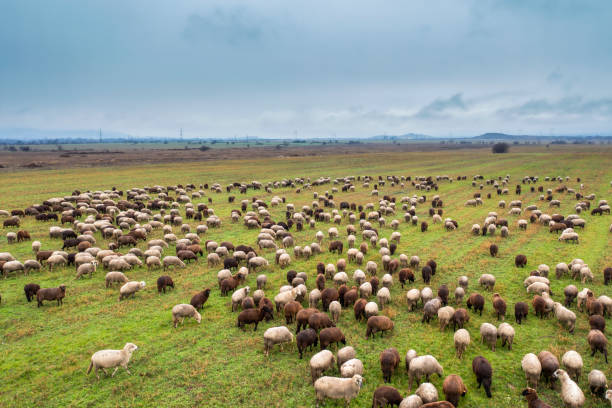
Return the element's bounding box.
[0,175,612,408]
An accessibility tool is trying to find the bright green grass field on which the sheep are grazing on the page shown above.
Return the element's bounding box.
[0,146,612,407]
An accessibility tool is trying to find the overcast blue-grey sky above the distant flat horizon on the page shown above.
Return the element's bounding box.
[0,0,612,138]
